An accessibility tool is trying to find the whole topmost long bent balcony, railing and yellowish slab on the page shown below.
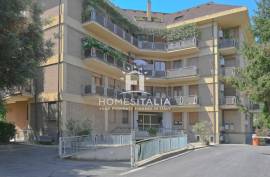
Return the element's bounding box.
[83,10,199,58]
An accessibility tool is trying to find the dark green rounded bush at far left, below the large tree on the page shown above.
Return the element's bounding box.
[0,121,16,143]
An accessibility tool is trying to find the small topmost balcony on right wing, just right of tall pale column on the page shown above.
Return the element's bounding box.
[219,39,238,55]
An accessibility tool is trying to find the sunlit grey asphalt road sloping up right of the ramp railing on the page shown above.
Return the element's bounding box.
[123,145,270,177]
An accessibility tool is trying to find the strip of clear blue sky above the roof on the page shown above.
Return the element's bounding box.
[111,0,256,16]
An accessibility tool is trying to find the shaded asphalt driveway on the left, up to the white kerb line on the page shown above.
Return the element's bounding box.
[0,145,130,177]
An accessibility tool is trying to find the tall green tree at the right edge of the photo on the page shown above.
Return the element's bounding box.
[229,0,270,128]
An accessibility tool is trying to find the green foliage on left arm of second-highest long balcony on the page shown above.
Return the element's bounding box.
[82,36,127,62]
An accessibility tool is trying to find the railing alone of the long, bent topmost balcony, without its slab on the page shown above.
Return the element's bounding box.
[86,10,198,51]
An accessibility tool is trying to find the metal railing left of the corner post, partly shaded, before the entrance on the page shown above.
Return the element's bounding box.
[59,135,132,158]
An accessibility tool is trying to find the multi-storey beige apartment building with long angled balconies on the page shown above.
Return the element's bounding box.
[2,0,254,143]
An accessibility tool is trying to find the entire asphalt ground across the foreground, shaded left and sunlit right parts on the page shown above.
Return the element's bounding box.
[0,145,270,177]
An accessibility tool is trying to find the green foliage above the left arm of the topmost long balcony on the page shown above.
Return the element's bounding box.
[82,0,139,34]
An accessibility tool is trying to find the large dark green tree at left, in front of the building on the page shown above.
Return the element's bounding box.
[0,0,53,115]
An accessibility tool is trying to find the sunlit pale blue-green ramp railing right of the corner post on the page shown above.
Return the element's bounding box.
[131,134,187,167]
